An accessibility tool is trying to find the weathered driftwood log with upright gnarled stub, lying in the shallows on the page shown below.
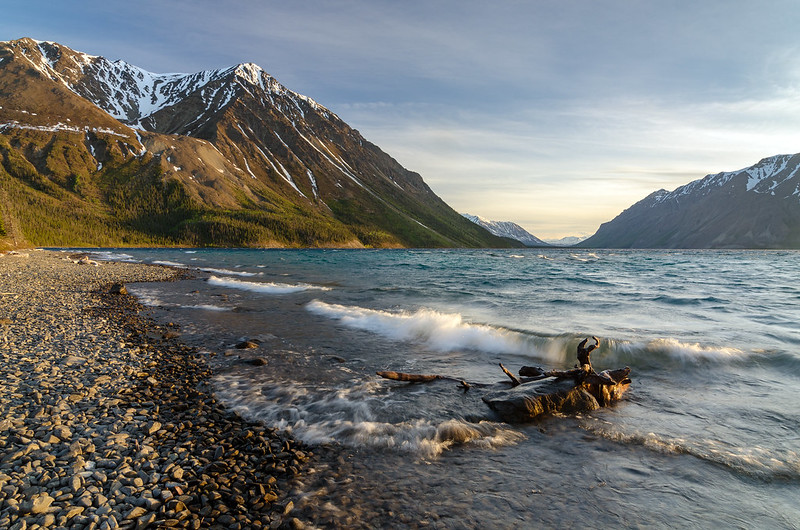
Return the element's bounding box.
[377,337,631,423]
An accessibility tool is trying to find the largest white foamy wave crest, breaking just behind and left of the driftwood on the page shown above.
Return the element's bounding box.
[306,300,539,355]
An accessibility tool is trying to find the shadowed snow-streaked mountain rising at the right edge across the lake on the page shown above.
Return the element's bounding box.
[580,154,800,248]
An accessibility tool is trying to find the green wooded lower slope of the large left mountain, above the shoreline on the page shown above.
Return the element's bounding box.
[0,123,507,247]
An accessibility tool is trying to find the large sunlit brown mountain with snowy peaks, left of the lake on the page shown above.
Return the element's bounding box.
[0,38,511,247]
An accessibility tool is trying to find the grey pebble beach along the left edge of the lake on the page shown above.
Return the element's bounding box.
[0,250,310,529]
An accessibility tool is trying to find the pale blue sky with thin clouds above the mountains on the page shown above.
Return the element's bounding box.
[0,0,800,238]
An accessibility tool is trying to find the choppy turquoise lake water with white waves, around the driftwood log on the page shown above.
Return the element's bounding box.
[76,249,800,528]
